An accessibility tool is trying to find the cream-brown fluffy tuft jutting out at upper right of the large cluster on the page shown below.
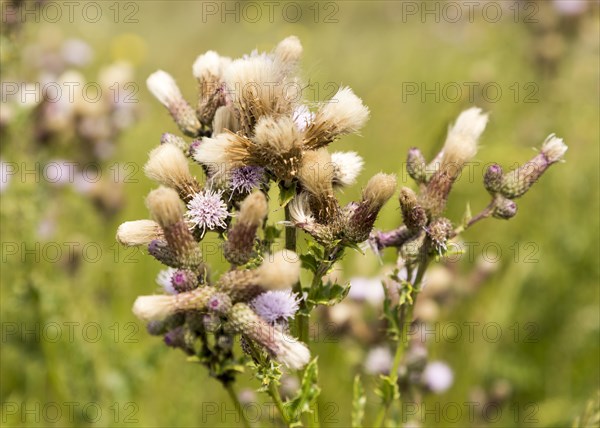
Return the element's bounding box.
[304,87,369,150]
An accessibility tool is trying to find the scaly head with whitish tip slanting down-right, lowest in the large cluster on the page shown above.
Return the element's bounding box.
[228,303,310,370]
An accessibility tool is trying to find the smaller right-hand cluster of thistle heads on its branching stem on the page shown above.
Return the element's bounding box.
[369,107,567,267]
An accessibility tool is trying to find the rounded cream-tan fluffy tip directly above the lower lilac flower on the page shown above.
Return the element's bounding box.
[257,250,300,290]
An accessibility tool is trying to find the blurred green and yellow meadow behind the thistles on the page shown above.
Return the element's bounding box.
[0,1,600,427]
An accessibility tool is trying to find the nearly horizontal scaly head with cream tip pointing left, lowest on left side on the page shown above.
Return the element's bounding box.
[133,287,216,321]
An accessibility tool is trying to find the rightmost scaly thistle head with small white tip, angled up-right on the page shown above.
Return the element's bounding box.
[500,134,567,199]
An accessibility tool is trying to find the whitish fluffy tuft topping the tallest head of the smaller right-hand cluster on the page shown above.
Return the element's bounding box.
[442,107,488,168]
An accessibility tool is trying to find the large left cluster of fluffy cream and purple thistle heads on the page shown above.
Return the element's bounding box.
[117,37,396,368]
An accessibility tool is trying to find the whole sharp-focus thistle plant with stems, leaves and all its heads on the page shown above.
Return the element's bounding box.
[117,36,566,426]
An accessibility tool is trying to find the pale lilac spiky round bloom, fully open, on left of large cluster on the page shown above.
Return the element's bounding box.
[185,189,229,234]
